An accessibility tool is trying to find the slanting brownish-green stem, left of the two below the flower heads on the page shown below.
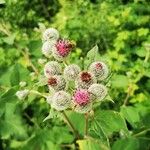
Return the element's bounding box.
[62,111,80,139]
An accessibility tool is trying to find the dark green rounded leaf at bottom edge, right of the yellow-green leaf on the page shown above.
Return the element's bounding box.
[112,138,139,150]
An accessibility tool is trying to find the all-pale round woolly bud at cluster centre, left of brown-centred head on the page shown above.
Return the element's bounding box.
[64,64,81,80]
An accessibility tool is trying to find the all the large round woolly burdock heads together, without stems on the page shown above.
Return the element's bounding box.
[42,28,109,113]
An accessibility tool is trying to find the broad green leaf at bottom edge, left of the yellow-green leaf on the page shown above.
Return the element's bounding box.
[22,126,74,150]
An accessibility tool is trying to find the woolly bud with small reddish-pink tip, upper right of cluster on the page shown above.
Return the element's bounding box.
[89,61,109,80]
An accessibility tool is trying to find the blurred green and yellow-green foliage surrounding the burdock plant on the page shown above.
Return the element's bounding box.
[0,0,150,150]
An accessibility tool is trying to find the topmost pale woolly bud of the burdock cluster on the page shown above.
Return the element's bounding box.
[43,28,59,41]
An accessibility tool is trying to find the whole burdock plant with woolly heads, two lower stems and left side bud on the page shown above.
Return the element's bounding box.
[16,28,109,141]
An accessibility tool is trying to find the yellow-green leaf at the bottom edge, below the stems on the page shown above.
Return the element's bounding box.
[77,139,109,150]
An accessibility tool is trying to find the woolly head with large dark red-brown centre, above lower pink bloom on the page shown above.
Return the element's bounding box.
[76,71,96,89]
